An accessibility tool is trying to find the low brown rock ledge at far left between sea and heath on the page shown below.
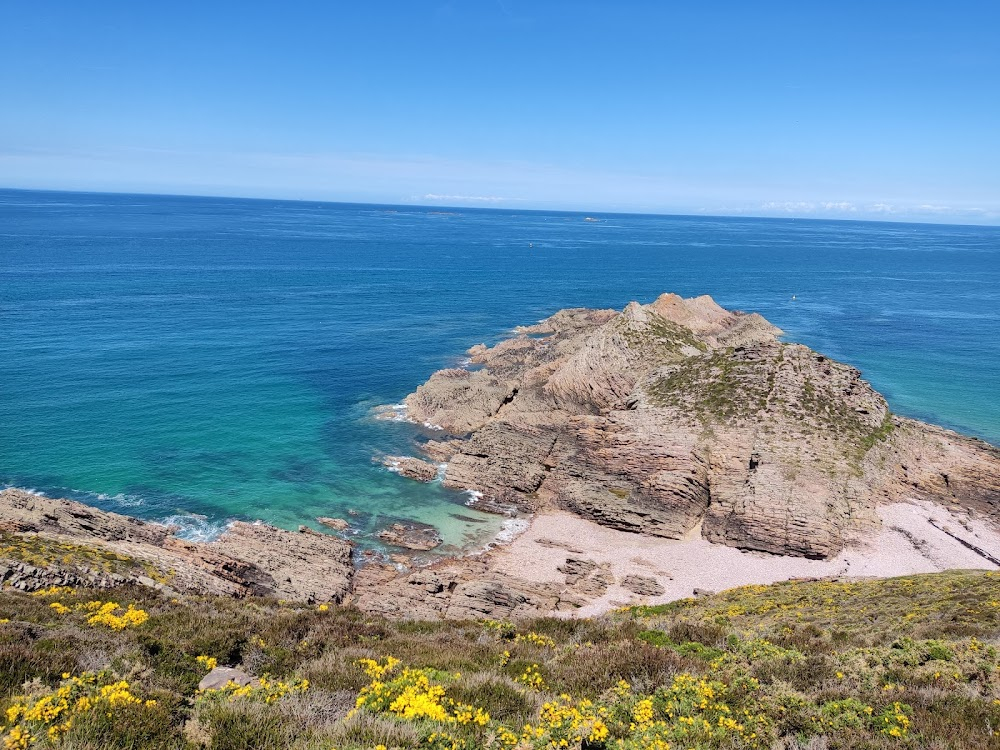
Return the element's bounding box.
[0,490,354,602]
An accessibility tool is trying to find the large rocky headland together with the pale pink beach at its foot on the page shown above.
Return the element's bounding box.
[352,294,1000,617]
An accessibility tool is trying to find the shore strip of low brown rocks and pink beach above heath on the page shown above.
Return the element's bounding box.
[0,490,1000,619]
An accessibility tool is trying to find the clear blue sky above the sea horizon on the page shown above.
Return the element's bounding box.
[0,0,1000,224]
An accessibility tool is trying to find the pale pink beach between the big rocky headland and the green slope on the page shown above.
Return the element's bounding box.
[490,500,1000,617]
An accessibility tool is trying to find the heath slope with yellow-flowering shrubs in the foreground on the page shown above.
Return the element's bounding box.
[0,572,1000,750]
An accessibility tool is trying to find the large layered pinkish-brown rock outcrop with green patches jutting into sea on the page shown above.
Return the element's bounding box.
[390,294,1000,557]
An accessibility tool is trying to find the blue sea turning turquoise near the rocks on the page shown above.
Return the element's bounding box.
[0,191,1000,544]
